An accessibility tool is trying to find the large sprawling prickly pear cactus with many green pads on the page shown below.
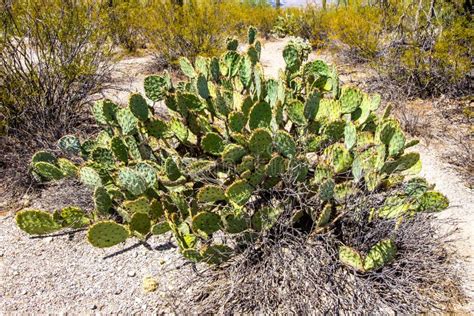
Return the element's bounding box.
[17,28,448,272]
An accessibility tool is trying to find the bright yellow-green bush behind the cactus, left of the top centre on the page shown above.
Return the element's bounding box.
[146,0,276,63]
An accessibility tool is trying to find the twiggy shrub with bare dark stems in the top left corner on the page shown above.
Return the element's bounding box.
[0,0,110,141]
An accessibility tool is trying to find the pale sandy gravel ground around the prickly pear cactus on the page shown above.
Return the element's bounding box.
[0,40,474,314]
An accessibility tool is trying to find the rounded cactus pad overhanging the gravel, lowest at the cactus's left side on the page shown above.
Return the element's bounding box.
[87,221,129,248]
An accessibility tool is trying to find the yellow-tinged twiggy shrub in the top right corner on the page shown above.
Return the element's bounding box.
[378,1,474,96]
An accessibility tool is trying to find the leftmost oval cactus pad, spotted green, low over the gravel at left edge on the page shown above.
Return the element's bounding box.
[15,210,61,235]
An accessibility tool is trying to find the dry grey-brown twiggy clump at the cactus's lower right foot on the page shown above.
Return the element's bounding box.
[181,213,465,314]
